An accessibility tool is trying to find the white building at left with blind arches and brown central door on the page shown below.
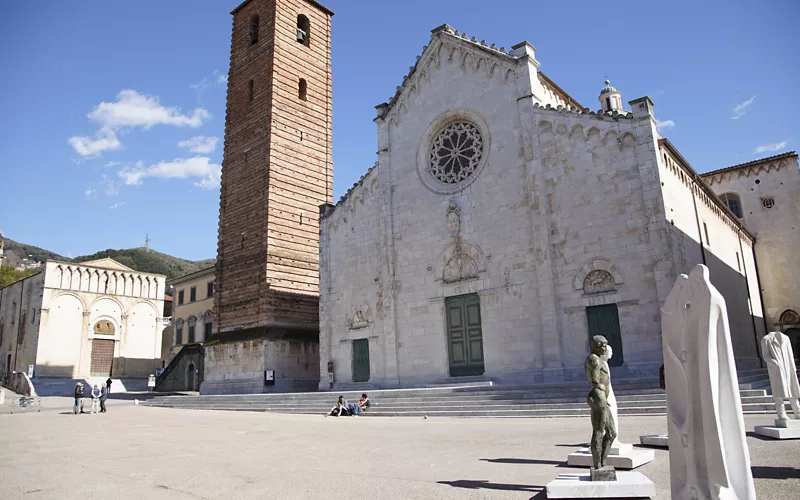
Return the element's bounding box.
[0,259,169,378]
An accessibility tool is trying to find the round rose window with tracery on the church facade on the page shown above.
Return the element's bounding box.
[430,122,483,184]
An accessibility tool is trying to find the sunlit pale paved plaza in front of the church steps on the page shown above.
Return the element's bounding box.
[0,395,800,500]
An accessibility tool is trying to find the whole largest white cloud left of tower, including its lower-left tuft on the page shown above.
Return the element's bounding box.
[69,89,211,157]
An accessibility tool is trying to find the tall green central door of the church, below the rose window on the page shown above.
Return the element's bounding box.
[445,294,484,377]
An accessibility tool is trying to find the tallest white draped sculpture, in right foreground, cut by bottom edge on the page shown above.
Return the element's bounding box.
[661,265,756,500]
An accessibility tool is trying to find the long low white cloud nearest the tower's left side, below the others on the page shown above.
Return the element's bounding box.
[119,156,222,189]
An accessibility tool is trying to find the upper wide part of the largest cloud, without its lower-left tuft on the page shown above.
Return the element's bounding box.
[89,89,211,130]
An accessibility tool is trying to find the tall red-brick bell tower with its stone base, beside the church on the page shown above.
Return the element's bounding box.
[206,0,333,394]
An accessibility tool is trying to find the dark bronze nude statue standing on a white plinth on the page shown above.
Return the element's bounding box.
[583,335,617,481]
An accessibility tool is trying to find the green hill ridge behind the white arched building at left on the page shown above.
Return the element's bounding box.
[3,238,216,279]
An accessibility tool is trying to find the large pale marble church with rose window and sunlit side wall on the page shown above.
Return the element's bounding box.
[319,25,765,390]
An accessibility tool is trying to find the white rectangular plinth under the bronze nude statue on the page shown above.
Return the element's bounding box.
[546,471,656,498]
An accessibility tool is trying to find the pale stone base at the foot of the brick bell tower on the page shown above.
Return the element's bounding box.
[200,327,319,395]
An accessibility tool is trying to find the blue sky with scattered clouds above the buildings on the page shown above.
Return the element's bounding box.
[0,0,800,260]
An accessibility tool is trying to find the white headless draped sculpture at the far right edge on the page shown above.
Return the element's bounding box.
[761,332,800,420]
